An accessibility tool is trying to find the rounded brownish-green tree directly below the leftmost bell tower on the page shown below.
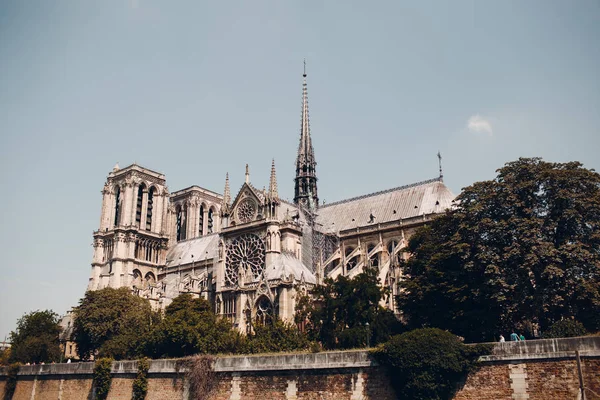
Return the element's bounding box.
[73,288,158,360]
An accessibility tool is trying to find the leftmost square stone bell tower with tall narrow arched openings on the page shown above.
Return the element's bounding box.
[88,164,169,290]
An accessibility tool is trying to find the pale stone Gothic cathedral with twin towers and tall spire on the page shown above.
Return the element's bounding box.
[88,72,454,332]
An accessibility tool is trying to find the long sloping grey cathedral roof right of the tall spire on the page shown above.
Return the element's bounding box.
[316,178,455,233]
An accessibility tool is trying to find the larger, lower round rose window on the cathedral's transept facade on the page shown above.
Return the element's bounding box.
[225,234,265,285]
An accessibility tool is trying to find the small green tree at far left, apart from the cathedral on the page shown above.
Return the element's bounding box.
[10,310,61,363]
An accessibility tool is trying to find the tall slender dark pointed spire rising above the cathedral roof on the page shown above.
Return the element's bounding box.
[294,62,319,210]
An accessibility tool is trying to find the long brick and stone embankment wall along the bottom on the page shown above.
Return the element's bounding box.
[0,337,600,400]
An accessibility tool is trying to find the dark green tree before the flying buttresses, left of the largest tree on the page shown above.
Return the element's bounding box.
[296,268,401,349]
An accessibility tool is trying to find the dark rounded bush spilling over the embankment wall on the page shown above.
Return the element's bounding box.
[373,328,491,400]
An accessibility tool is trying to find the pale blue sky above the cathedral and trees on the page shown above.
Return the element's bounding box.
[0,0,600,340]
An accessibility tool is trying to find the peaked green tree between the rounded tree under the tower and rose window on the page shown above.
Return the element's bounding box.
[145,293,243,357]
